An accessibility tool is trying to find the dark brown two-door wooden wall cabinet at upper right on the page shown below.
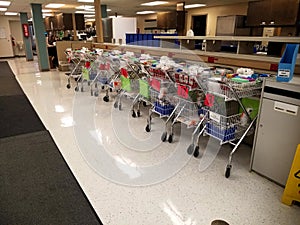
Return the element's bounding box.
[247,0,299,26]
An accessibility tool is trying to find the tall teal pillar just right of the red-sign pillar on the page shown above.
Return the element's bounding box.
[31,3,50,71]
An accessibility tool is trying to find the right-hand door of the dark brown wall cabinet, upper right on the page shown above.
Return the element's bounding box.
[270,0,299,26]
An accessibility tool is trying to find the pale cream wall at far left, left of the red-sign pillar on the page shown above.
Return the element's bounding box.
[0,16,18,57]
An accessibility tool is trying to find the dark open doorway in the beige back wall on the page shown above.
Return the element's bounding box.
[192,15,207,49]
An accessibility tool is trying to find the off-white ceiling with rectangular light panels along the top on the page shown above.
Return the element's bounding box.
[0,0,248,16]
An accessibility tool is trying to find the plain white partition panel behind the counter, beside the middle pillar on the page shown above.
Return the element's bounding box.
[112,17,136,43]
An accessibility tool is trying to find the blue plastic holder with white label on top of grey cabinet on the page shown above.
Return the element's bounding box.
[276,44,299,82]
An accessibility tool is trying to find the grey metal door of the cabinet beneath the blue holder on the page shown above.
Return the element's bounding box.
[252,98,300,185]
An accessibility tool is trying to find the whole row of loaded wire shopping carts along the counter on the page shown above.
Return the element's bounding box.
[63,48,262,177]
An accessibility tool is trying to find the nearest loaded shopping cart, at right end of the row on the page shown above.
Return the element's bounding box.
[187,76,262,178]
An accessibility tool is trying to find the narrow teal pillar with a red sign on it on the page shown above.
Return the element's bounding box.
[20,12,33,61]
